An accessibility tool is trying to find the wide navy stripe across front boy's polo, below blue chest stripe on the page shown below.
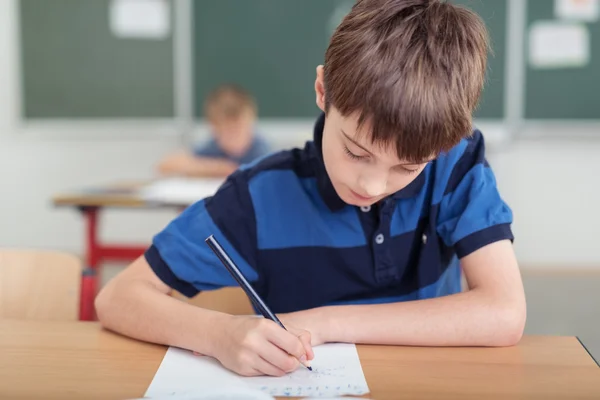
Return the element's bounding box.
[256,225,455,312]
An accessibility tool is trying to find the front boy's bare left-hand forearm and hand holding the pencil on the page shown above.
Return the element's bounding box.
[95,257,314,376]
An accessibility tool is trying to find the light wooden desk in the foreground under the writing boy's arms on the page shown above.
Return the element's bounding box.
[0,320,600,400]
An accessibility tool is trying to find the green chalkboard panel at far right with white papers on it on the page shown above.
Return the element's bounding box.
[524,0,600,120]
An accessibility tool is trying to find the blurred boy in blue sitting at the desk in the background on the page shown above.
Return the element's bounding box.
[158,85,270,177]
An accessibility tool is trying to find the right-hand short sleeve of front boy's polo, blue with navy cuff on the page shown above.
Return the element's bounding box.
[437,131,514,258]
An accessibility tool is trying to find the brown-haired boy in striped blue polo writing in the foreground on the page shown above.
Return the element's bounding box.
[96,0,525,375]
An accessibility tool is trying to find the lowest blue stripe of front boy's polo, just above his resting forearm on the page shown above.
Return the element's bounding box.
[329,263,462,305]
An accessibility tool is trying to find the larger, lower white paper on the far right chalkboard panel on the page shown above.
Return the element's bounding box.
[529,22,590,68]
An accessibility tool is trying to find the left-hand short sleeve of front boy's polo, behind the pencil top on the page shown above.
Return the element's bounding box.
[145,171,258,297]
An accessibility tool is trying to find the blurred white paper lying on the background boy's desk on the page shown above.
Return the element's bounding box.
[139,178,225,205]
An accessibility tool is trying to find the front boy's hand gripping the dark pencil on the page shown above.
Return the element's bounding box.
[214,316,314,376]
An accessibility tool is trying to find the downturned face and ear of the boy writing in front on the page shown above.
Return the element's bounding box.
[315,66,427,206]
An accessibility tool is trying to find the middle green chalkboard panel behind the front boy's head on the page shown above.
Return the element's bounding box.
[193,0,507,119]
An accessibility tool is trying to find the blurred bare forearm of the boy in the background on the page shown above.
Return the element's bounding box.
[158,152,238,177]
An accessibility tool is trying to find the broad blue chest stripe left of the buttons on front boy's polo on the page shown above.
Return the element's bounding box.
[250,170,366,250]
